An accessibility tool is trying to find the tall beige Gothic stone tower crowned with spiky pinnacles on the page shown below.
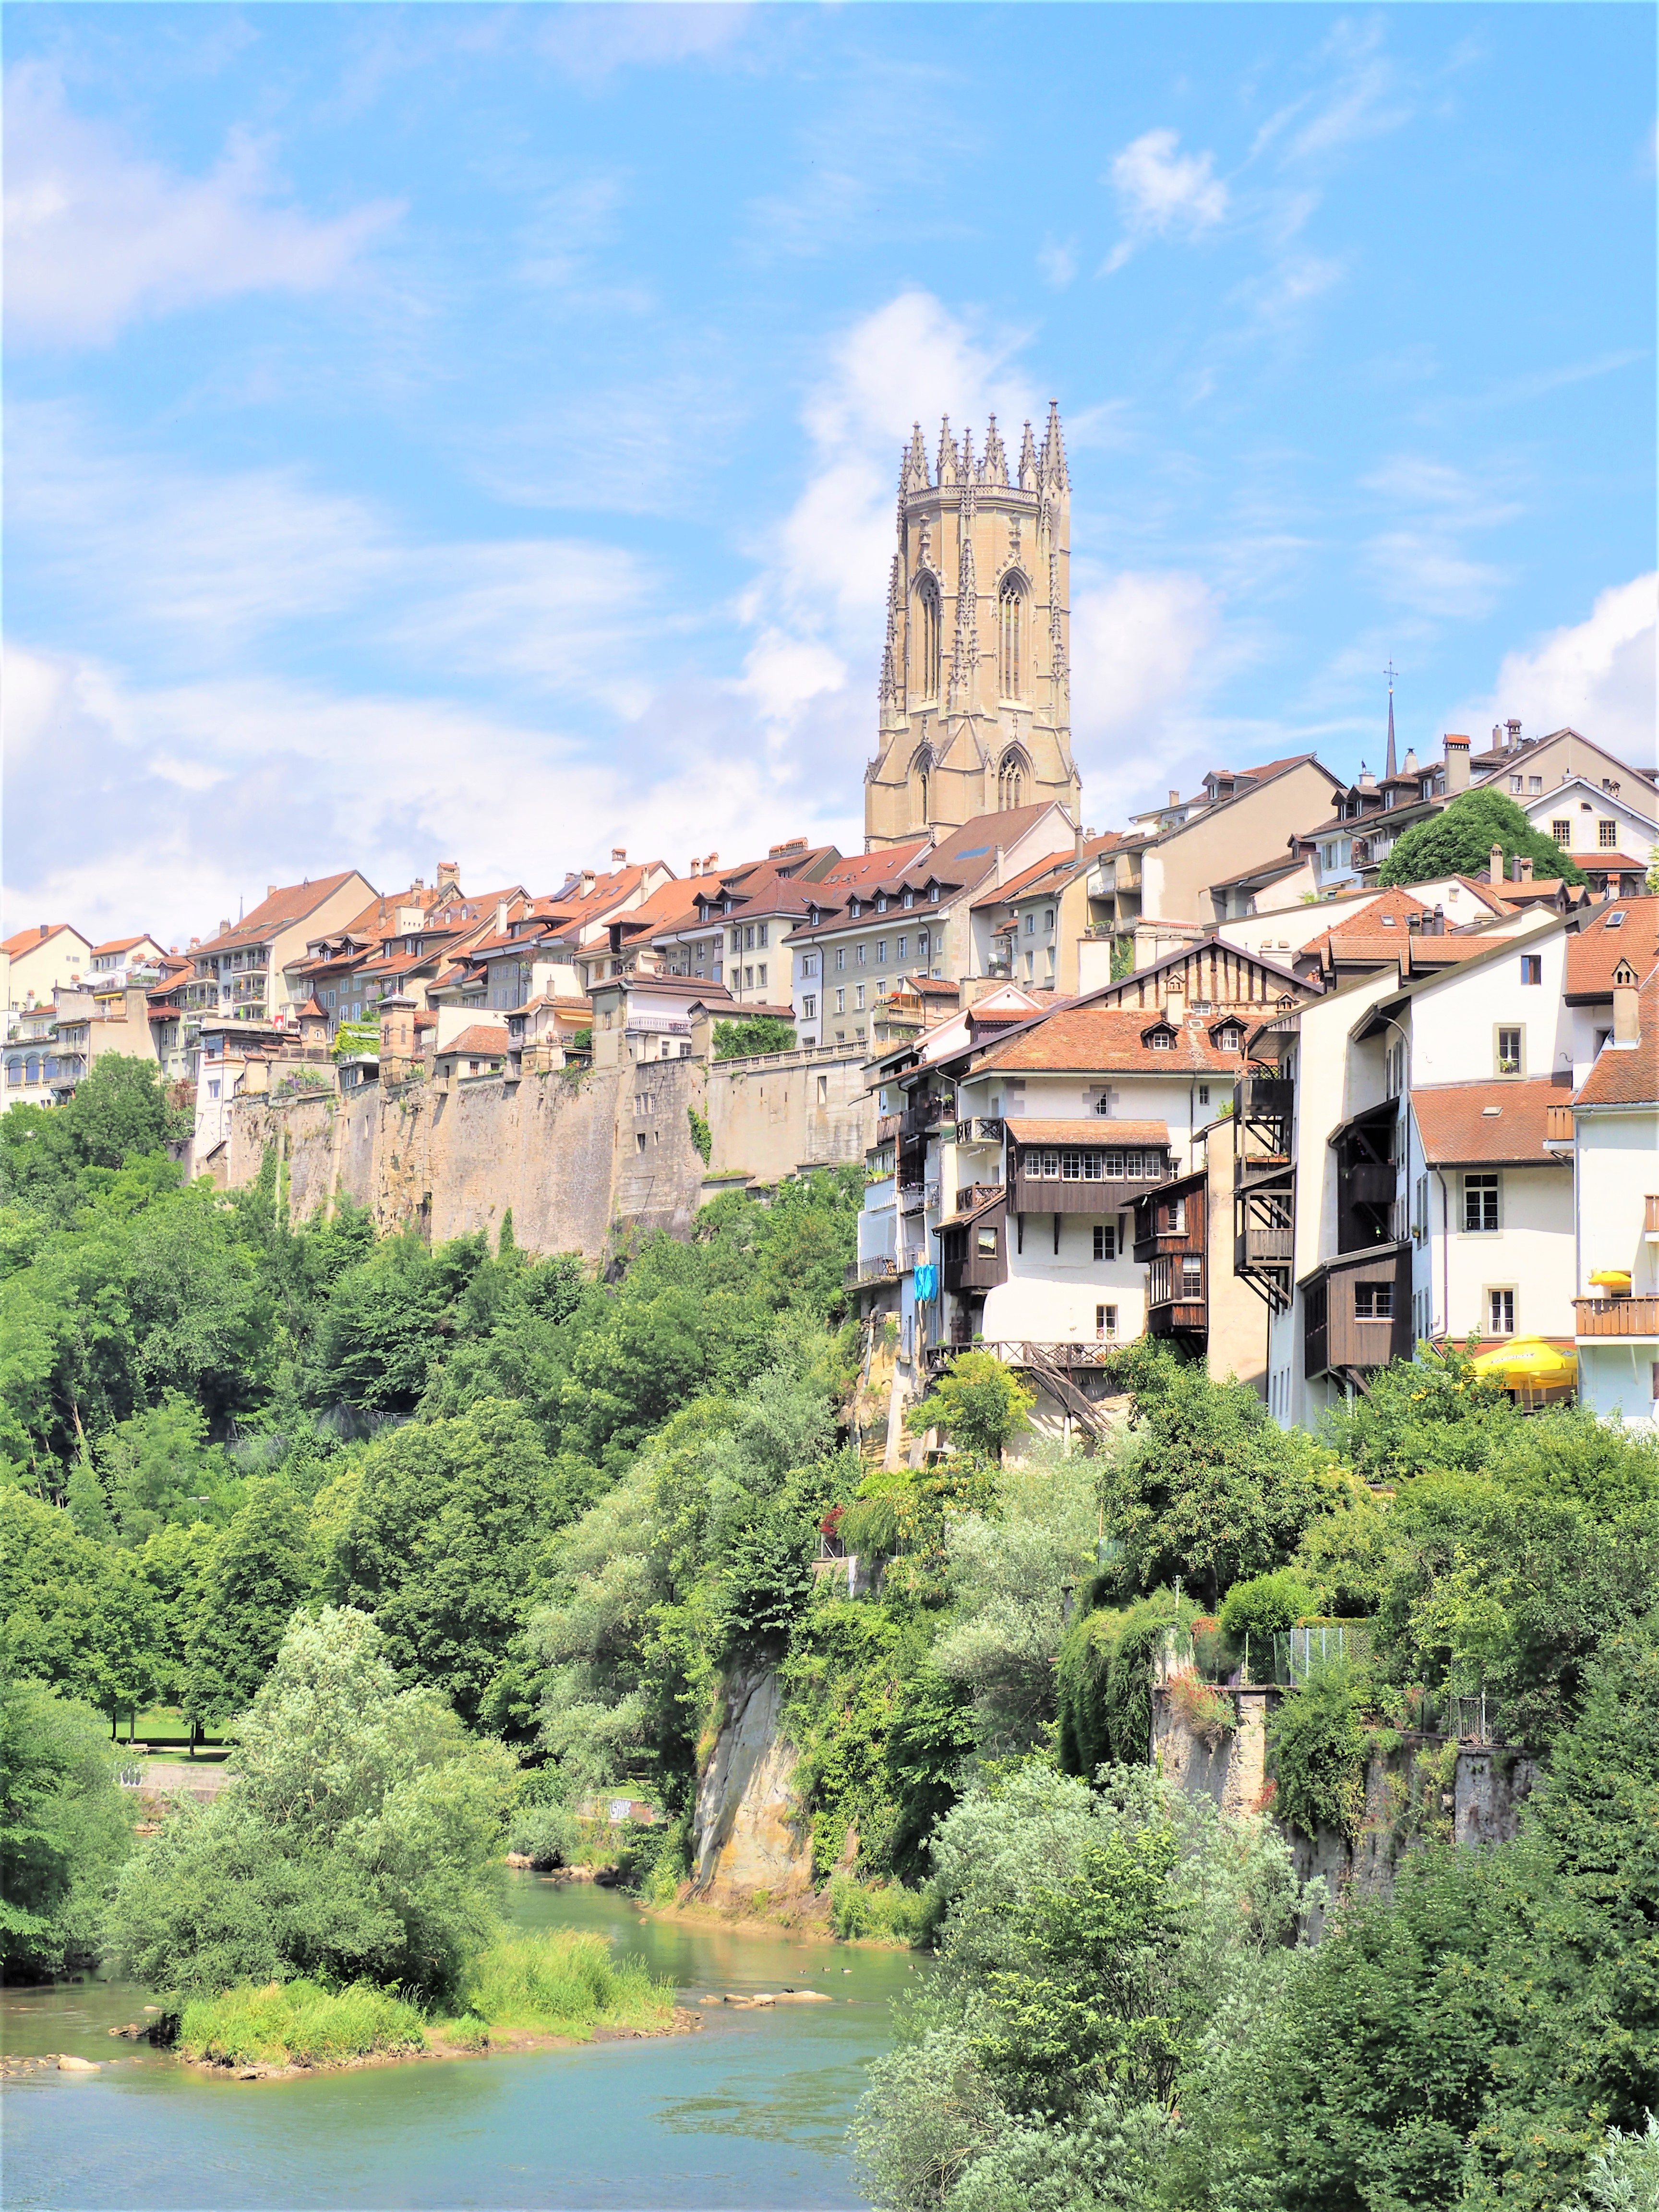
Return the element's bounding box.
[865,403,1082,849]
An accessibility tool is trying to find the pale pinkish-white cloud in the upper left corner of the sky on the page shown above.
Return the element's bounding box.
[4,62,403,345]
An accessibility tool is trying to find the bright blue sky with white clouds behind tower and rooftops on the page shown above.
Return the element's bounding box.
[4,4,1655,942]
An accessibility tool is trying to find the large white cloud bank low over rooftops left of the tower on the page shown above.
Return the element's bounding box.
[4,646,858,942]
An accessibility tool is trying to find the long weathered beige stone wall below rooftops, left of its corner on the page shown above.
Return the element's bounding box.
[226,1059,703,1259]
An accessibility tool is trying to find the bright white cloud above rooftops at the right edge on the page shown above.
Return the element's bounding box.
[1447,573,1659,768]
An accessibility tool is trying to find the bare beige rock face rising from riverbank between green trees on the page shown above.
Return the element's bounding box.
[690,1670,812,1904]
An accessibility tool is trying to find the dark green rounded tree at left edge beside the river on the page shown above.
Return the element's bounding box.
[0,1666,132,1982]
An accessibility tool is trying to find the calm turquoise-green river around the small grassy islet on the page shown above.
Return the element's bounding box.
[0,1874,923,2212]
